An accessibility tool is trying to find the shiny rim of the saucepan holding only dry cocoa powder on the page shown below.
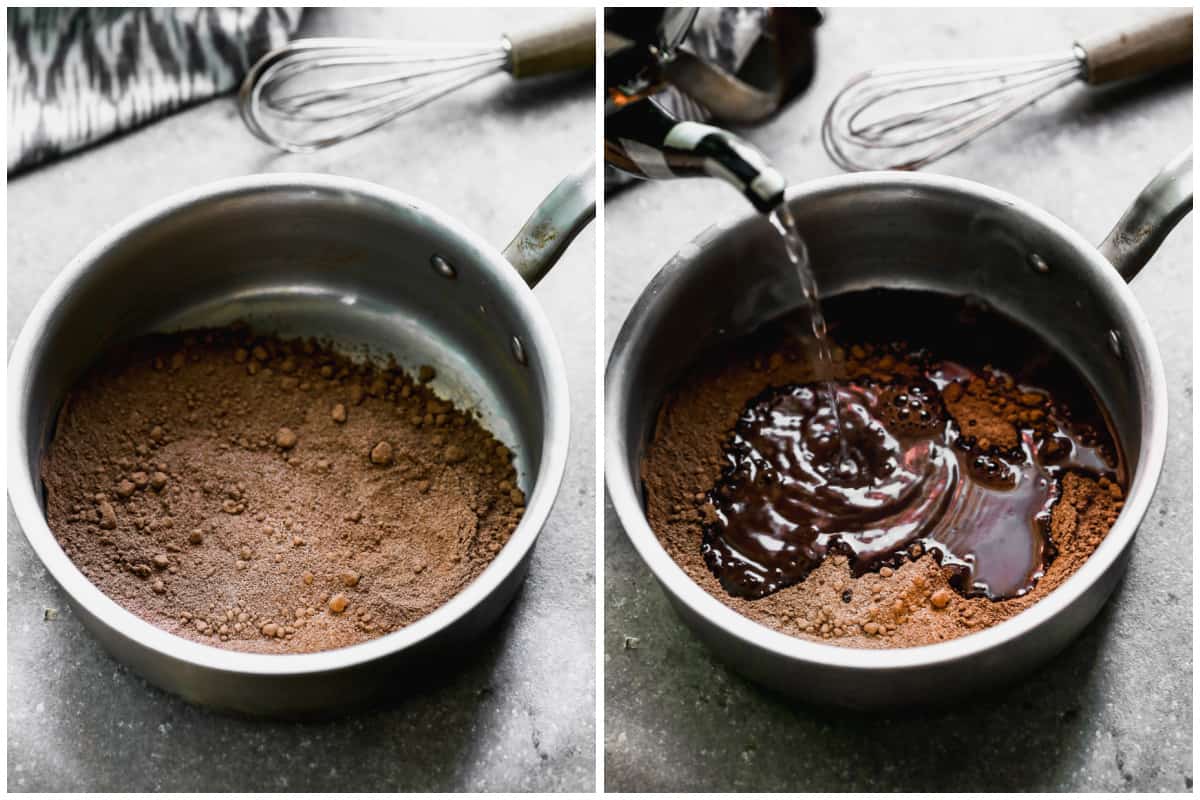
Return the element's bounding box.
[8,173,570,676]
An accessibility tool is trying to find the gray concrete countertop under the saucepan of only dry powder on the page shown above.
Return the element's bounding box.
[7,8,595,792]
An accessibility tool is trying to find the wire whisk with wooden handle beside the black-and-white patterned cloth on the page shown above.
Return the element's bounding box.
[239,11,595,152]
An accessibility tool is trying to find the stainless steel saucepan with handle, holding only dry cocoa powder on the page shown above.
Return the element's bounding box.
[8,163,595,715]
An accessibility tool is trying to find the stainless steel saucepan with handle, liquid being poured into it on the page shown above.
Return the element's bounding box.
[605,152,1192,709]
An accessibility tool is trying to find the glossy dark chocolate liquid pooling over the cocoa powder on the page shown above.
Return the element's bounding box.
[702,290,1123,600]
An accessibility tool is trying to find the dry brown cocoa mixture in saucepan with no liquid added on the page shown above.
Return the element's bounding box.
[42,326,524,654]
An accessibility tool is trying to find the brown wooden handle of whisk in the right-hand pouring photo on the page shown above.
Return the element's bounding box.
[1075,10,1192,85]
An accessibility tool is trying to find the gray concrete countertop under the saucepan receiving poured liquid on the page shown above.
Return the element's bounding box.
[604,8,1193,792]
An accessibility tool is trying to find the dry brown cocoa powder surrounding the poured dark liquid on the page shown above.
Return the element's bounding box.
[642,293,1123,648]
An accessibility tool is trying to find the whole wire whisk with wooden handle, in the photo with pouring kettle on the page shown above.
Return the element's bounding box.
[821,11,1192,172]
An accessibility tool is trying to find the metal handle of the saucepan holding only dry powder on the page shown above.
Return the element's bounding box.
[504,158,596,287]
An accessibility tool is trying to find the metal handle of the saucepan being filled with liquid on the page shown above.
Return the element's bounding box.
[1100,148,1192,282]
